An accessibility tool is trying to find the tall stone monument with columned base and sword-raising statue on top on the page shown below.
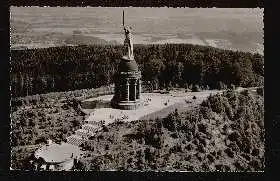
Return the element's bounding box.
[111,11,141,110]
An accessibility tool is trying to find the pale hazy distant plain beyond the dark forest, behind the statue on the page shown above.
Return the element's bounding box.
[10,7,263,54]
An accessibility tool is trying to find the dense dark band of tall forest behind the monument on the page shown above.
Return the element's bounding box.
[10,44,264,97]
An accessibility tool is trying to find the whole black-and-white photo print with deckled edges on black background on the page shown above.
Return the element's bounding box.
[10,6,265,172]
